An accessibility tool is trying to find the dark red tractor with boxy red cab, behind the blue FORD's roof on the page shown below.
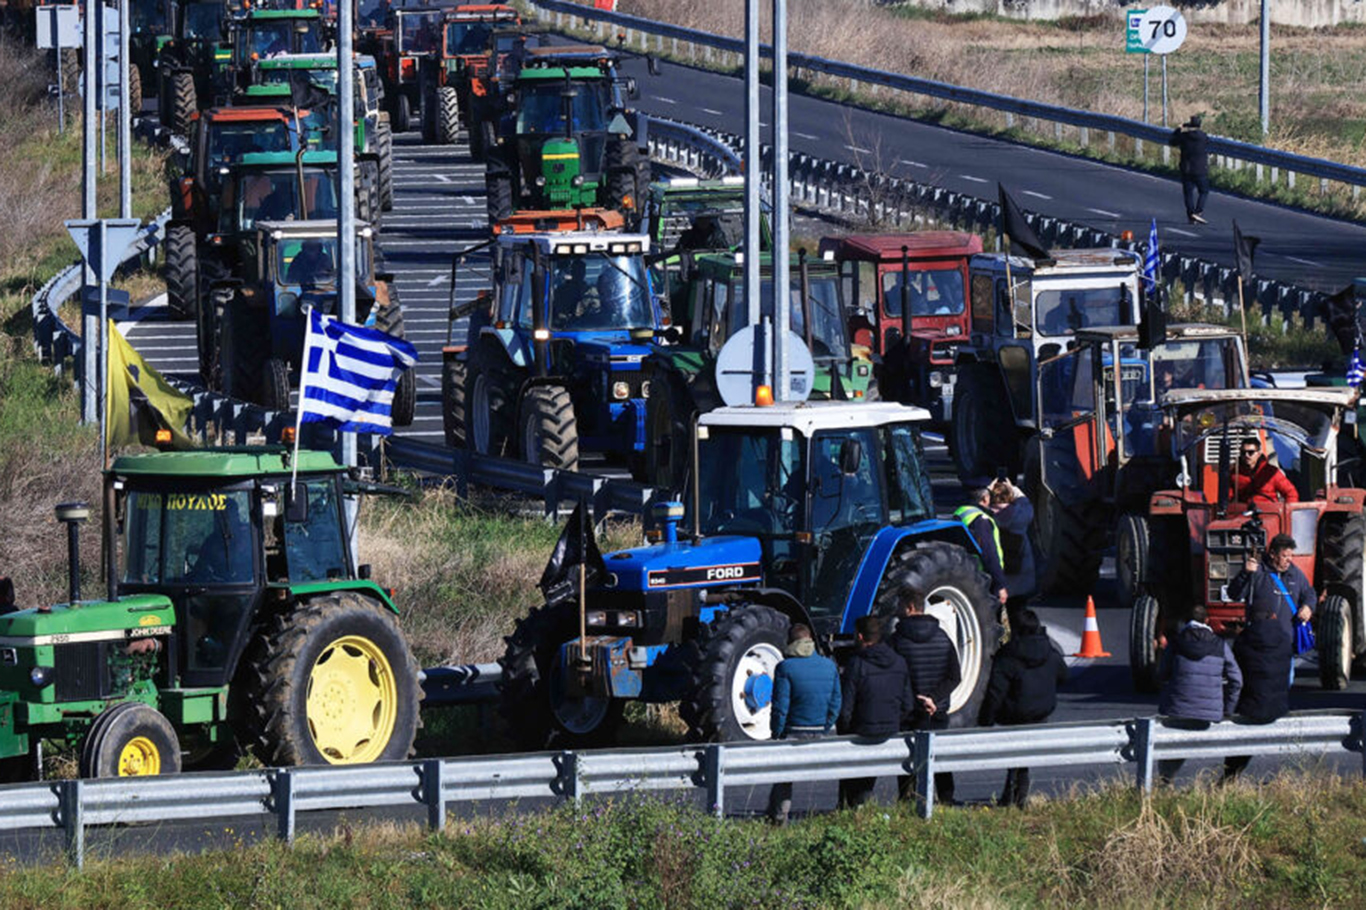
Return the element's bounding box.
[821,231,982,426]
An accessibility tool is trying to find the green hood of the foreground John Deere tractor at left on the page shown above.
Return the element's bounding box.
[0,594,175,648]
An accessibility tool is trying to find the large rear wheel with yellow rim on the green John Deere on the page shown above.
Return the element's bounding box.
[246,592,422,765]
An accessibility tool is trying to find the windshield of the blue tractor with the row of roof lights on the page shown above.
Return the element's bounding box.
[543,253,654,332]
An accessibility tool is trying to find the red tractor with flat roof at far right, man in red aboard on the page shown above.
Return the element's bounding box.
[1120,388,1366,690]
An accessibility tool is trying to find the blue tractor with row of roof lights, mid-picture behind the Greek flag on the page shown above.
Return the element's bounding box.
[441,209,664,470]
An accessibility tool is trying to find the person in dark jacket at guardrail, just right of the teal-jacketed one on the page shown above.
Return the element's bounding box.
[840,616,915,809]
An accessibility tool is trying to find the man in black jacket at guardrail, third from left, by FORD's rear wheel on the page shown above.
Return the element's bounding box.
[892,590,963,806]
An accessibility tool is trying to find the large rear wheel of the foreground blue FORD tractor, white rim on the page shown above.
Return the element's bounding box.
[873,541,1004,727]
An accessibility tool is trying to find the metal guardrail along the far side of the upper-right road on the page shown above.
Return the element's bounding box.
[527,0,1366,186]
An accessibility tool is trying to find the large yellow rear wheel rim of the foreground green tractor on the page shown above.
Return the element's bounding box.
[305,635,399,765]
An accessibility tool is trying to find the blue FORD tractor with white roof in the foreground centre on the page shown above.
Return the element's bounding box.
[500,402,1001,747]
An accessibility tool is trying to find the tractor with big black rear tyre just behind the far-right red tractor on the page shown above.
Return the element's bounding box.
[1025,324,1247,600]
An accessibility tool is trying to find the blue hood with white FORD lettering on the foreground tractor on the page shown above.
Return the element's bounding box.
[605,537,762,590]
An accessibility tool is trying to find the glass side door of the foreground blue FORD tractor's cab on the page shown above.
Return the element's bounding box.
[802,428,887,620]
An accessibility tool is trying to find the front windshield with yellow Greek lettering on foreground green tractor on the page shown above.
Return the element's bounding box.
[120,489,258,585]
